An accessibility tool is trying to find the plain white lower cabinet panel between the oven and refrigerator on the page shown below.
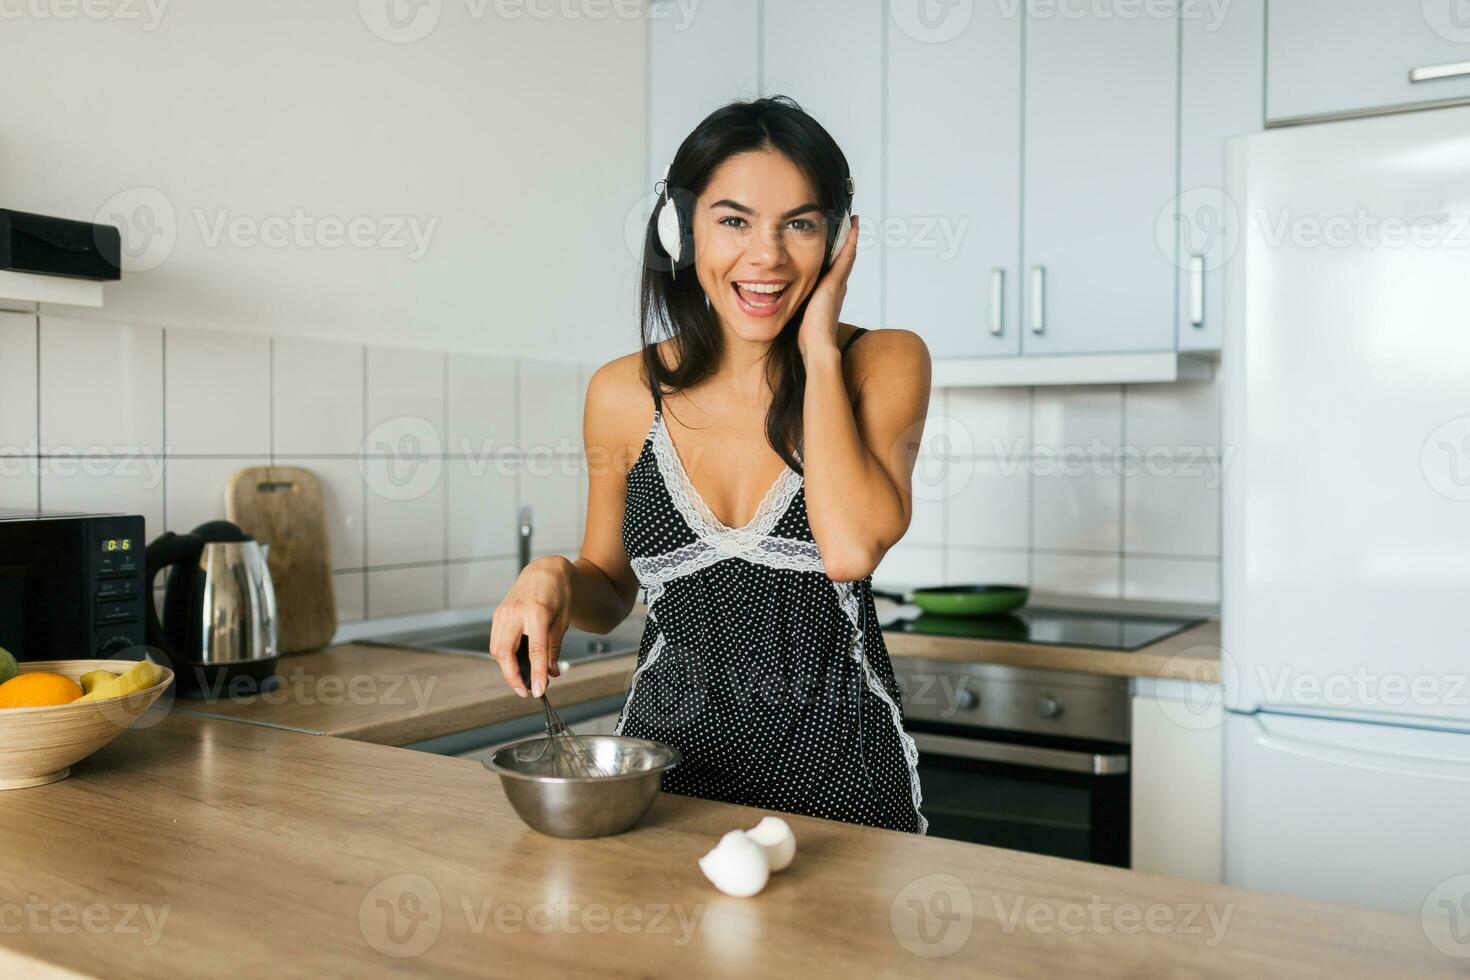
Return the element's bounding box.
[1130,679,1225,882]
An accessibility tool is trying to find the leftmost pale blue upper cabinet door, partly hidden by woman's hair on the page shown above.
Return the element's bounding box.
[648,0,760,191]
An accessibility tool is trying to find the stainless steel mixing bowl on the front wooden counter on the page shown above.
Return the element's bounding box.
[481,735,684,837]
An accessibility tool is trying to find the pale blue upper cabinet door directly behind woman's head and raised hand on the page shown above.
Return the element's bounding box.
[770,0,888,328]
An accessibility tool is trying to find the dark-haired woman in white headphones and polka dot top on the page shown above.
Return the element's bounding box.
[490,97,929,833]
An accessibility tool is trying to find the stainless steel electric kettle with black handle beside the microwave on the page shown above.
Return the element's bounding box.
[144,520,278,699]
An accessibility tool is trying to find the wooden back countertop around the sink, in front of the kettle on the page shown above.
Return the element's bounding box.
[175,644,635,745]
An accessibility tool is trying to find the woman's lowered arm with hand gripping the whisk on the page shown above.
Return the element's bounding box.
[490,356,642,698]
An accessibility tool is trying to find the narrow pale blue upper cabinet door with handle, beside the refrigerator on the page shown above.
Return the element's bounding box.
[1163,0,1266,351]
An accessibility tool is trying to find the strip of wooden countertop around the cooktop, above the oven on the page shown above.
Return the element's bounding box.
[883,619,1220,683]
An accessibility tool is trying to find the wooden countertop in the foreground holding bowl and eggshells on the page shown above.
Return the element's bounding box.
[0,714,1446,980]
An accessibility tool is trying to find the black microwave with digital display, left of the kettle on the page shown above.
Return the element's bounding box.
[0,508,148,661]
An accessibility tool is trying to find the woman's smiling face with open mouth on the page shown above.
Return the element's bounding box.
[694,150,826,341]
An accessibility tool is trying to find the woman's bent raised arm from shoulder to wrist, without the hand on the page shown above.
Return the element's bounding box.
[801,331,929,582]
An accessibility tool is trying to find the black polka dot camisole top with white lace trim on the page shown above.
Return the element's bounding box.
[616,328,928,833]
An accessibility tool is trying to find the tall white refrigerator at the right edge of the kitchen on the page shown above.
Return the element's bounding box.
[1217,107,1470,915]
